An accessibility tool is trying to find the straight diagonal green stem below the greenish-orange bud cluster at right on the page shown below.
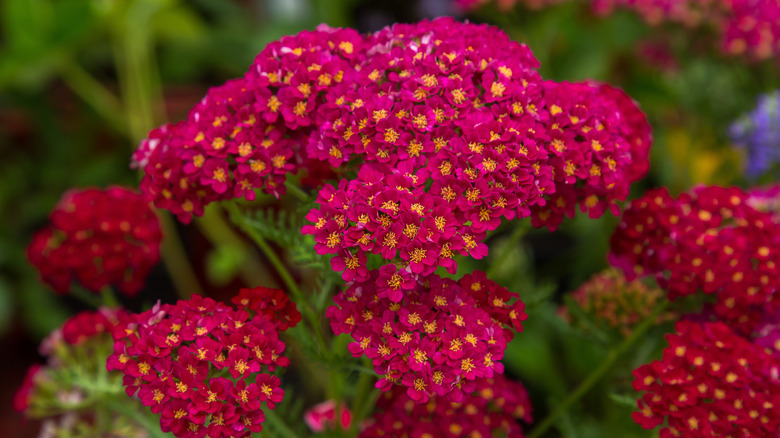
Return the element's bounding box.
[527,301,669,438]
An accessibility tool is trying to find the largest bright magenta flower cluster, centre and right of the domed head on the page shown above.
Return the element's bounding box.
[303,19,651,281]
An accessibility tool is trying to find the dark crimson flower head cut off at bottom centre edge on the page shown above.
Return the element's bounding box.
[359,375,532,438]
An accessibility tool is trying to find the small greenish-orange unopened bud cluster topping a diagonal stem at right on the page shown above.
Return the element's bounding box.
[561,269,674,337]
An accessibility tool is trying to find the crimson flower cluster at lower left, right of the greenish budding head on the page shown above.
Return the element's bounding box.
[107,290,297,438]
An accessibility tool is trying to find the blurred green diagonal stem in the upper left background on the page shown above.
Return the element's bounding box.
[59,61,127,135]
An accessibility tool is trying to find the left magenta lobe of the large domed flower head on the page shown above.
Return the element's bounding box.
[133,26,363,223]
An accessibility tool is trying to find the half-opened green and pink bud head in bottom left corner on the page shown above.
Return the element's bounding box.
[13,308,147,438]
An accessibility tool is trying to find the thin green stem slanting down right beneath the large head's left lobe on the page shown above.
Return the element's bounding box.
[223,202,329,354]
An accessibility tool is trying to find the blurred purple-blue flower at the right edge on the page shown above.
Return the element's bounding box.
[729,90,780,179]
